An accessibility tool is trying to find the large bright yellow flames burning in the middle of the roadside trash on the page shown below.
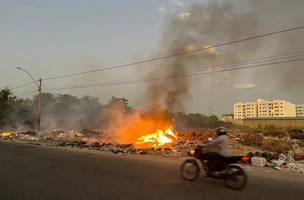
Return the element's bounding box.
[136,128,177,147]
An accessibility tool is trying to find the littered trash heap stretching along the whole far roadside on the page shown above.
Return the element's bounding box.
[0,128,304,166]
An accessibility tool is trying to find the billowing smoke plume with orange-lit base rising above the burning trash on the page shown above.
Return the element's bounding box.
[106,0,301,143]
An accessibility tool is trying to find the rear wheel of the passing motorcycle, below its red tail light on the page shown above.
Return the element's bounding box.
[225,165,247,190]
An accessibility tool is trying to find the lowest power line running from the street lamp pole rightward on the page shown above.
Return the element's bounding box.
[45,57,304,91]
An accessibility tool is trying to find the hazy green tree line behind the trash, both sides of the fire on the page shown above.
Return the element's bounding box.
[0,89,226,131]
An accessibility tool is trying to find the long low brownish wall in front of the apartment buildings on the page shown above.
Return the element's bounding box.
[242,118,304,128]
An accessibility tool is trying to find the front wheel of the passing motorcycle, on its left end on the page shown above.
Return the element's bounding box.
[180,159,200,181]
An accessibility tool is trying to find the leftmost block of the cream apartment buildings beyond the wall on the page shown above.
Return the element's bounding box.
[234,102,257,119]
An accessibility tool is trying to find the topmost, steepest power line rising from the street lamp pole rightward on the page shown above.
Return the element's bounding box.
[43,25,304,80]
